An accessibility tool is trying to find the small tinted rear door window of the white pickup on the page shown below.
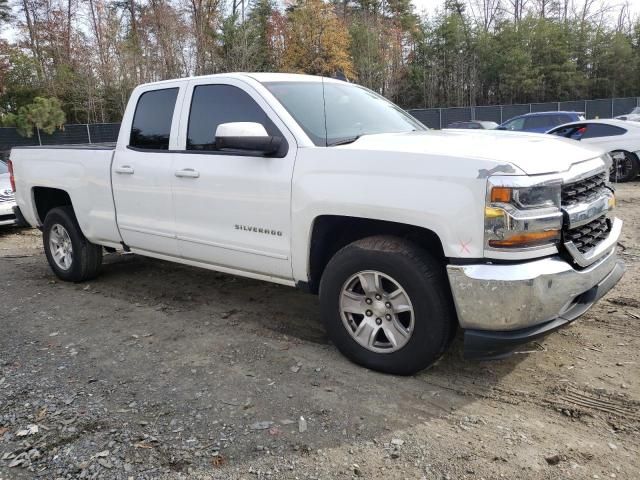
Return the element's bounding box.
[129,88,178,150]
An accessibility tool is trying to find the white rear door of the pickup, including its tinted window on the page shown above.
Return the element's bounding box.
[111,82,185,256]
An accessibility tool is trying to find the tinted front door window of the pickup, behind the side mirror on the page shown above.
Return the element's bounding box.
[187,85,282,150]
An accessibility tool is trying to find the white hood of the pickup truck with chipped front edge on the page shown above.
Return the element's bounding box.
[337,130,604,175]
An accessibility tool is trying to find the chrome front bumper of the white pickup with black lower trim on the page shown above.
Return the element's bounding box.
[447,247,625,358]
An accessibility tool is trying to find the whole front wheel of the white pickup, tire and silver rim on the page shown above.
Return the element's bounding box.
[320,236,457,375]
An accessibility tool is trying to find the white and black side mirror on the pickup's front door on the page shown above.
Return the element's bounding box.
[215,122,282,155]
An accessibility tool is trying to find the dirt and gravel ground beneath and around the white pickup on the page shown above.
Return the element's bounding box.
[0,182,640,480]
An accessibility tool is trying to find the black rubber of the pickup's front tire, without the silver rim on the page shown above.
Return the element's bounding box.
[320,236,457,375]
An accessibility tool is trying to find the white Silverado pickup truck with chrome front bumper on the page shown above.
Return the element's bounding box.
[10,74,624,374]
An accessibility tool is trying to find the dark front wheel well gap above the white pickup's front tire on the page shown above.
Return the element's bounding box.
[308,215,445,293]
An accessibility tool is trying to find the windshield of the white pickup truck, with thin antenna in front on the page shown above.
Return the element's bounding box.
[264,81,427,147]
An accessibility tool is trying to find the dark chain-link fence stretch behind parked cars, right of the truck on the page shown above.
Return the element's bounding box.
[409,97,640,128]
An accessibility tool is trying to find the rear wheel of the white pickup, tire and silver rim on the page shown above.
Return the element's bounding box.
[42,207,102,282]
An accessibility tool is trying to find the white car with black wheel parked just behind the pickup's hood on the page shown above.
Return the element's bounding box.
[547,119,640,182]
